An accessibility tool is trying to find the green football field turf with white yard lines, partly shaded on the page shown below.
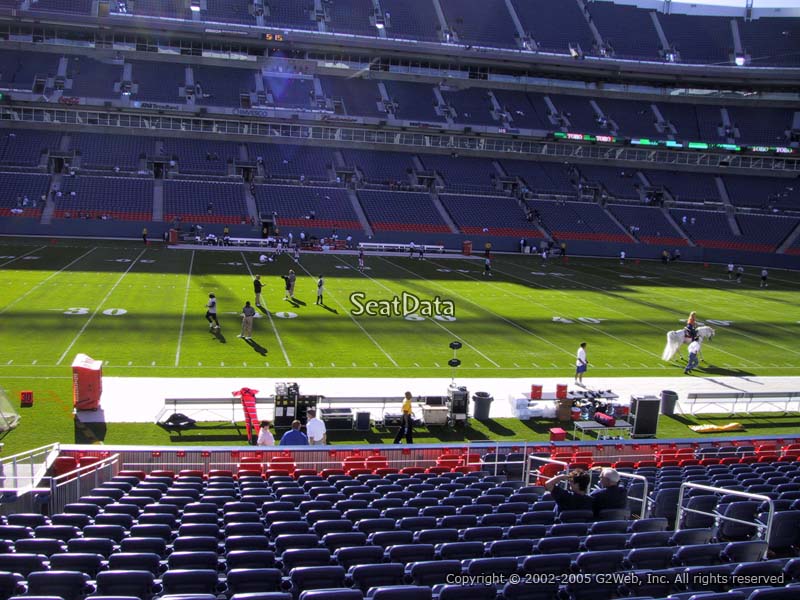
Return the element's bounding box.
[0,239,800,453]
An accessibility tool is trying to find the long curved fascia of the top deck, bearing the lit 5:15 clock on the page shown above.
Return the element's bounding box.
[0,11,800,92]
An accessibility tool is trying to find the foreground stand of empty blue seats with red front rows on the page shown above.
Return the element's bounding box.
[7,440,800,600]
